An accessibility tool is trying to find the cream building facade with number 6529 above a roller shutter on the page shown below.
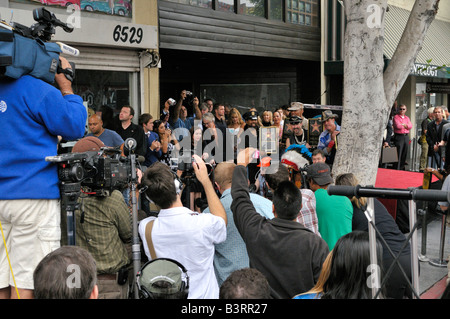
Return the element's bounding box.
[0,0,159,121]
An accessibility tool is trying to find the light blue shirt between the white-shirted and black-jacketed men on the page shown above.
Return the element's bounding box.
[203,188,274,286]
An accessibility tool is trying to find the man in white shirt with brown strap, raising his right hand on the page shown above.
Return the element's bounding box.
[139,155,227,299]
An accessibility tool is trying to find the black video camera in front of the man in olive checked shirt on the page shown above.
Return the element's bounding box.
[45,147,132,196]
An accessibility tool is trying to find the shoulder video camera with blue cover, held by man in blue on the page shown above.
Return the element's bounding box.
[0,8,79,84]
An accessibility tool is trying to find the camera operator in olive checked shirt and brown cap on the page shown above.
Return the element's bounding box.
[63,136,132,299]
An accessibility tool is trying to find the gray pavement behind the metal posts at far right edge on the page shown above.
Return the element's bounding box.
[416,216,450,294]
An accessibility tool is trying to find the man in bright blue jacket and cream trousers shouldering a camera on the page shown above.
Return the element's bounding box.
[0,57,87,298]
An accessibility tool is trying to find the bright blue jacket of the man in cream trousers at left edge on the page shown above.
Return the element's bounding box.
[0,75,87,200]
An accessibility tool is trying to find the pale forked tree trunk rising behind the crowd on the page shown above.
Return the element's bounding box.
[333,0,439,185]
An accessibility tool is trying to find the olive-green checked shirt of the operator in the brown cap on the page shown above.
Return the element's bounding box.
[63,190,132,274]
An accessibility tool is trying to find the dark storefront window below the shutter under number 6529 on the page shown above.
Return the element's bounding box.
[73,70,132,114]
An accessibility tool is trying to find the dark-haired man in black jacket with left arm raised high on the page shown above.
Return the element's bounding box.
[231,148,329,299]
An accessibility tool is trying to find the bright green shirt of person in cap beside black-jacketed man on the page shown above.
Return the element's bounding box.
[314,188,353,250]
